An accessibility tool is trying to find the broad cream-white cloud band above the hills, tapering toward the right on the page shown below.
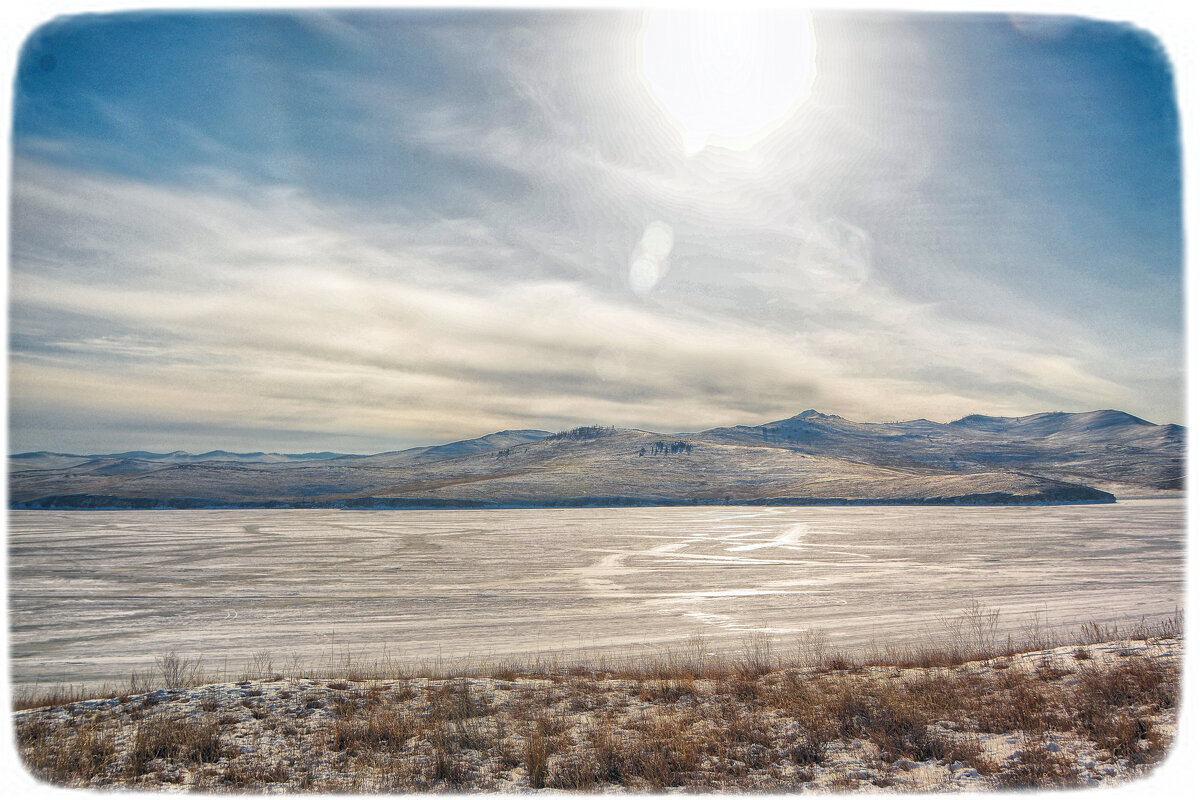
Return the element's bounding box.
[12,131,1171,449]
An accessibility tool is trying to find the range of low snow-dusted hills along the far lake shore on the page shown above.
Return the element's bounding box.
[8,410,1184,509]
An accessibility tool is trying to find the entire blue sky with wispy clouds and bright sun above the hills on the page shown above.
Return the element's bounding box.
[8,3,1184,453]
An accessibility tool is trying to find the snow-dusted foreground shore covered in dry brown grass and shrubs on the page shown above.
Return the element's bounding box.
[16,632,1182,793]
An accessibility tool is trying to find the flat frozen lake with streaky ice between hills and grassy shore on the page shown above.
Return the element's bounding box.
[8,499,1186,687]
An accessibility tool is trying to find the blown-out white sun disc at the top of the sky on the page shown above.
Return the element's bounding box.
[640,8,814,154]
